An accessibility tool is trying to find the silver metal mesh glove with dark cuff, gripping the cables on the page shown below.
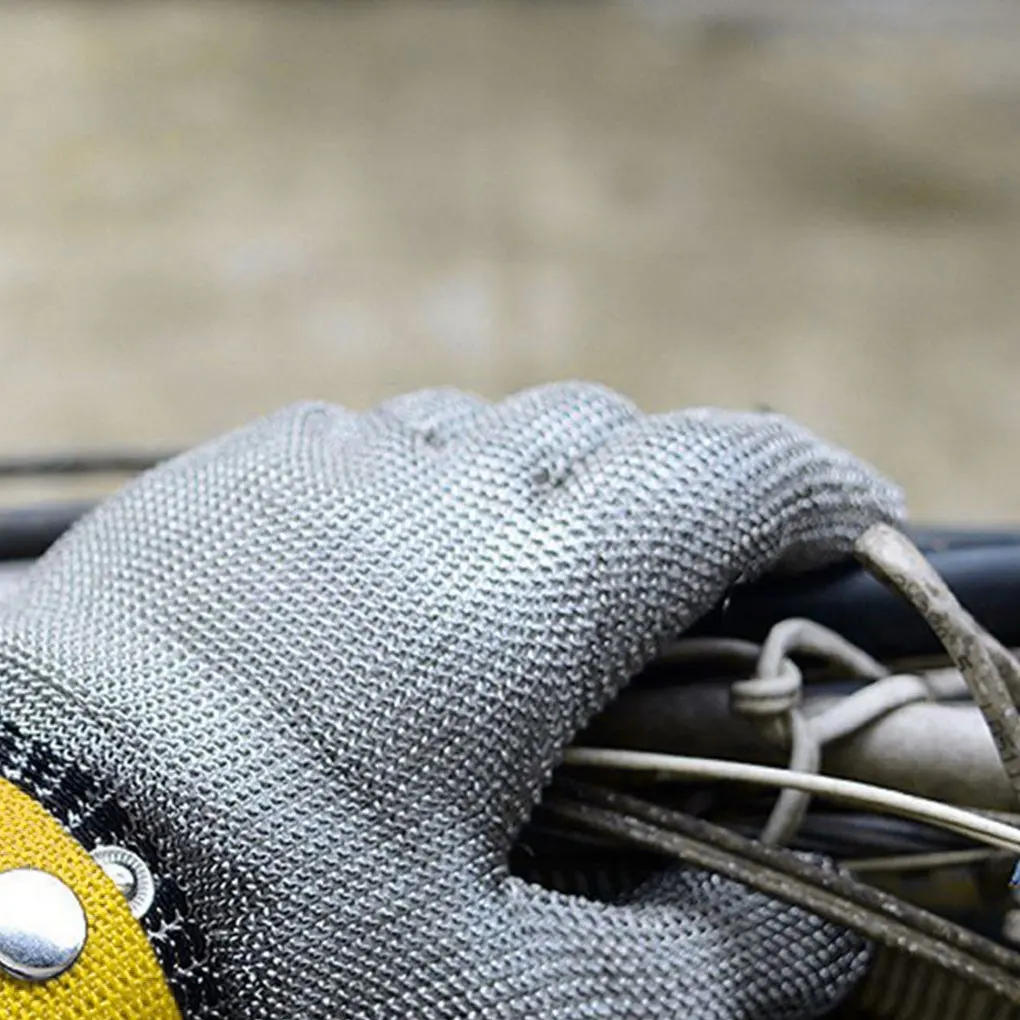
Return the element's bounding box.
[0,385,899,1020]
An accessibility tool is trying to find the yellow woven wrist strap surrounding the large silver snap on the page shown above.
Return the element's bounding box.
[0,779,181,1020]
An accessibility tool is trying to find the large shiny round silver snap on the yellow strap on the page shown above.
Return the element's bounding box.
[0,868,88,981]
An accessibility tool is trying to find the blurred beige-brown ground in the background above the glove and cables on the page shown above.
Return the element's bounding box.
[0,0,1020,520]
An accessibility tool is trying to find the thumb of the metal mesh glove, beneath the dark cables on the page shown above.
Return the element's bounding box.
[475,869,870,1020]
